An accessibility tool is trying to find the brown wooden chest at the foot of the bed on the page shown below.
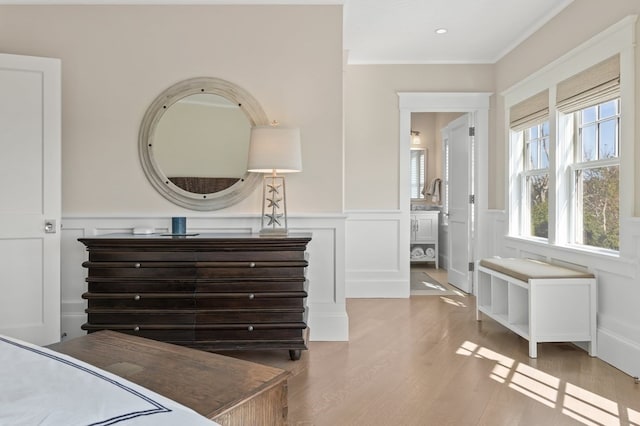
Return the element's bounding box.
[48,331,290,426]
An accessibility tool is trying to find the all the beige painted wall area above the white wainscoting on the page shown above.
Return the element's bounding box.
[0,4,640,216]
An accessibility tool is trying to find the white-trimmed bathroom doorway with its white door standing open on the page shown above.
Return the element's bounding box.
[399,93,490,293]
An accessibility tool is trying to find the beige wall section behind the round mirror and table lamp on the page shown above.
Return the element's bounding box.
[0,5,343,216]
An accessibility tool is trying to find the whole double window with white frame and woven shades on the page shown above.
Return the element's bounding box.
[503,17,640,261]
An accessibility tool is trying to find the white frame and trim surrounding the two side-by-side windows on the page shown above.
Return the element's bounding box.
[501,16,637,256]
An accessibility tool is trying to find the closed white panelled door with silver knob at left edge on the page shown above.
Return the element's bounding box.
[0,54,61,345]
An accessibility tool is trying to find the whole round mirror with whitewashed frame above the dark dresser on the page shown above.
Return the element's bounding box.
[138,77,268,210]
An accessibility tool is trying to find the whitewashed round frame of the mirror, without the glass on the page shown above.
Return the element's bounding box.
[138,77,269,211]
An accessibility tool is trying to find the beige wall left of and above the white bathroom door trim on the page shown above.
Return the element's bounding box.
[345,65,494,210]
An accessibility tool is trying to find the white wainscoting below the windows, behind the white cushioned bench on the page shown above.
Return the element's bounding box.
[483,211,640,377]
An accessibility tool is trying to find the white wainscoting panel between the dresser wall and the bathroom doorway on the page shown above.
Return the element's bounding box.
[346,211,409,298]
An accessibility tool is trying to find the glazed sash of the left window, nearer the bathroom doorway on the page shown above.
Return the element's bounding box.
[521,121,549,238]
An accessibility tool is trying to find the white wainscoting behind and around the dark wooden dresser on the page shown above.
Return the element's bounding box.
[61,214,349,341]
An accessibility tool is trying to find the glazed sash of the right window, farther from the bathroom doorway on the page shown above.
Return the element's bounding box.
[572,99,620,250]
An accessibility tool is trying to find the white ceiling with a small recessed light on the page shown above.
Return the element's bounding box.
[0,0,573,64]
